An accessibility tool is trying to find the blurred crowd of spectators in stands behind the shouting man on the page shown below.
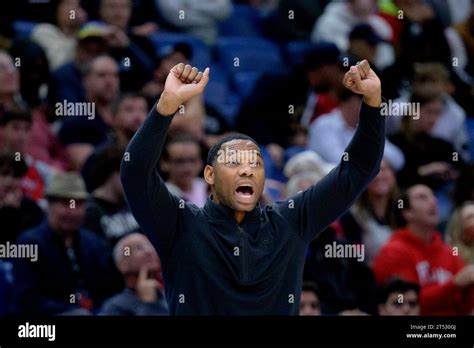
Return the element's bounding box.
[0,0,474,316]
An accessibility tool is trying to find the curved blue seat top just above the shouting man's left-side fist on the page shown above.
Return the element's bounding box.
[149,32,211,69]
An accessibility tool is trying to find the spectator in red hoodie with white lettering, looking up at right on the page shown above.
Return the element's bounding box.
[373,184,474,315]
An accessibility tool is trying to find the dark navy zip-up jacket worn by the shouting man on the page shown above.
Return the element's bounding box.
[121,103,385,315]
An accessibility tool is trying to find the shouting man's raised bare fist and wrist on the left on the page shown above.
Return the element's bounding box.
[156,63,209,116]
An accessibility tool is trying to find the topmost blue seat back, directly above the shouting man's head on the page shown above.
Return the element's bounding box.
[219,4,262,37]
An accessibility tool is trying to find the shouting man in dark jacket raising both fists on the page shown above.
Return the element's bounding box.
[121,61,385,315]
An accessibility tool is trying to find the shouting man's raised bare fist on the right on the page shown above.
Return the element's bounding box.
[343,59,382,107]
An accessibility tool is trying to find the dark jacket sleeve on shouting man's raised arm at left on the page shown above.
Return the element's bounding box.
[120,106,184,264]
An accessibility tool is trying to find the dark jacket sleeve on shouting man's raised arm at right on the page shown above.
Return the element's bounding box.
[280,103,385,242]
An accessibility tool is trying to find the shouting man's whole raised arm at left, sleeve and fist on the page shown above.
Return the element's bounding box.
[120,63,209,259]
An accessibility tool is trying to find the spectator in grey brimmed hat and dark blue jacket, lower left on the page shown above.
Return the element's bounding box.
[14,172,122,315]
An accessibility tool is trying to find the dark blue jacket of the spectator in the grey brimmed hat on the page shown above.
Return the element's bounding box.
[13,221,122,315]
